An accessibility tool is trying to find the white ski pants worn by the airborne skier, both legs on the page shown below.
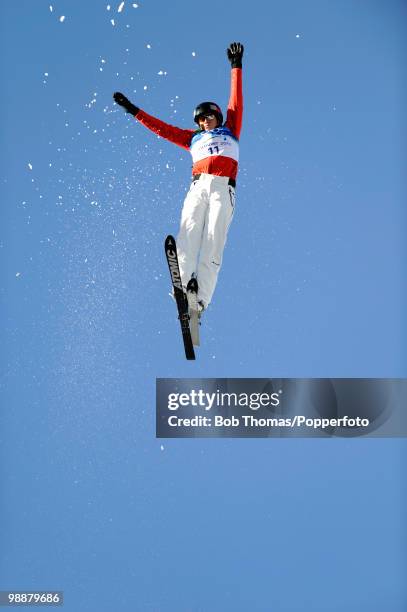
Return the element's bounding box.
[177,174,235,307]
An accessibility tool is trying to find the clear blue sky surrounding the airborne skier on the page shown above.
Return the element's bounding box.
[0,0,407,612]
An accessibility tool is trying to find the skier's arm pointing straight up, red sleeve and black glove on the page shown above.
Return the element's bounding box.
[225,43,244,138]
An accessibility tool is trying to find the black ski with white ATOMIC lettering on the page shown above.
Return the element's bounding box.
[165,236,195,359]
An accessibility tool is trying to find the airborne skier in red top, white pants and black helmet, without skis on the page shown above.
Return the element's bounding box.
[113,42,244,314]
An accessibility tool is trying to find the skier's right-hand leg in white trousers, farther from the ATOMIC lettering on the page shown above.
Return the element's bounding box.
[197,177,235,307]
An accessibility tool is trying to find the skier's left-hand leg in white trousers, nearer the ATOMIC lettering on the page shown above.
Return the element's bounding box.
[177,180,208,287]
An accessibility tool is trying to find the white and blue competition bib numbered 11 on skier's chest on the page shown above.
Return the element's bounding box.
[189,127,239,164]
